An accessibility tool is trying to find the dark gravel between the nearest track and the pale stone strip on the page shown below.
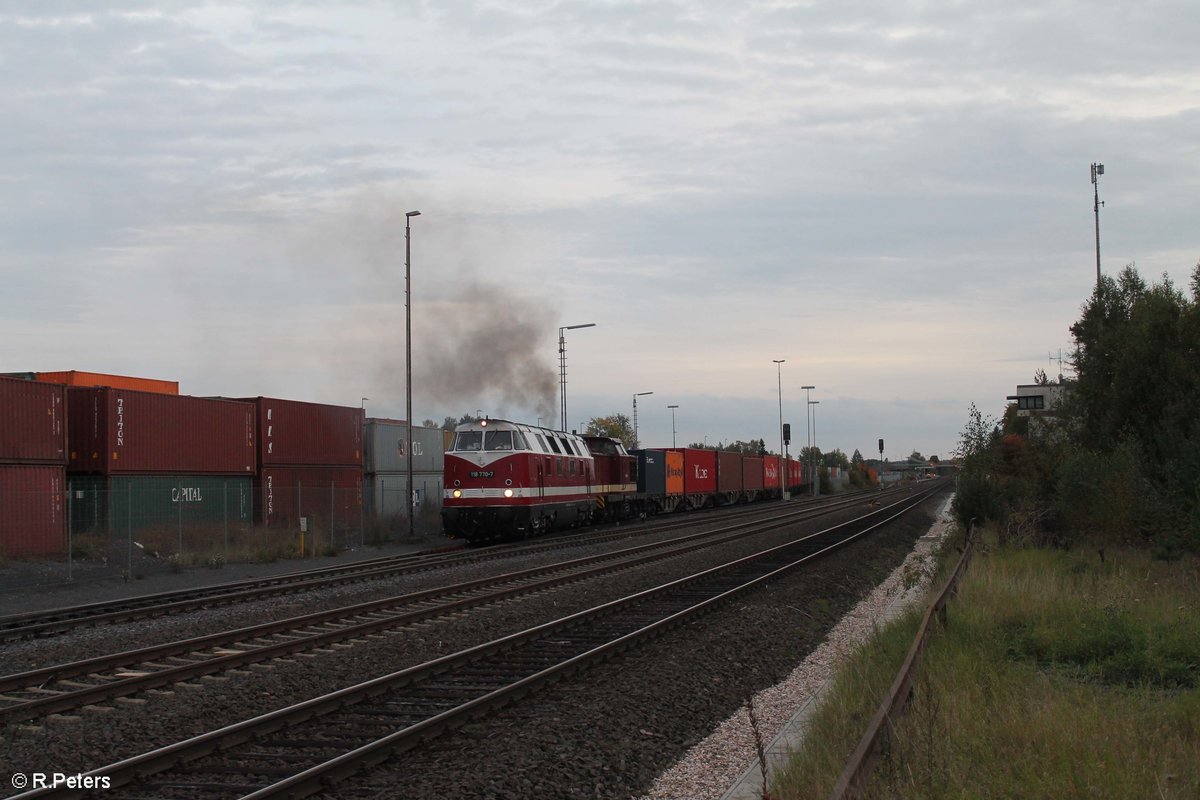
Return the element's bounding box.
[328,489,950,800]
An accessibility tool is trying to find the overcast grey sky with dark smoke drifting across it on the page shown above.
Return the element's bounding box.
[0,0,1200,457]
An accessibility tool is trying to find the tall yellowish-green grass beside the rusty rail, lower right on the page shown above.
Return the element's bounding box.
[772,532,1200,800]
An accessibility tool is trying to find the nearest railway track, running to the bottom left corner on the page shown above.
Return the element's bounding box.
[9,486,940,800]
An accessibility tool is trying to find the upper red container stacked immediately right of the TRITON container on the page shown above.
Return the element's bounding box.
[238,397,364,468]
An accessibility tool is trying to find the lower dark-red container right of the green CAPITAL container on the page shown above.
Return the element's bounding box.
[254,465,362,533]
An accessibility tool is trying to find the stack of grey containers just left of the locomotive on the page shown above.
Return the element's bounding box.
[364,417,445,518]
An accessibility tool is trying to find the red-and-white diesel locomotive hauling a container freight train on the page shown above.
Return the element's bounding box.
[442,420,809,543]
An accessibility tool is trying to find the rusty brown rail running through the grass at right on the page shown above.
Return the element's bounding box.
[828,521,974,800]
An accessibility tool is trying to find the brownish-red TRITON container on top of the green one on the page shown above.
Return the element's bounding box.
[67,386,257,475]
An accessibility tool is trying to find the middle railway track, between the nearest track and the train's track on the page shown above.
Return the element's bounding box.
[0,491,883,723]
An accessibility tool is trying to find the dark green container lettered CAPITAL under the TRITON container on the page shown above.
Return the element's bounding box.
[67,475,254,536]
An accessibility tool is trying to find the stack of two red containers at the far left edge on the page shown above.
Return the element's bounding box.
[0,378,66,557]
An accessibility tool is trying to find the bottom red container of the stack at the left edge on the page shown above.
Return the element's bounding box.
[0,464,67,557]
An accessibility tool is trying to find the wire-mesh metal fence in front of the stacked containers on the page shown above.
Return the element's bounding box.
[0,476,442,588]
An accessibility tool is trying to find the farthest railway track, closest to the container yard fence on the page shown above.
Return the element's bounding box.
[0,494,883,642]
